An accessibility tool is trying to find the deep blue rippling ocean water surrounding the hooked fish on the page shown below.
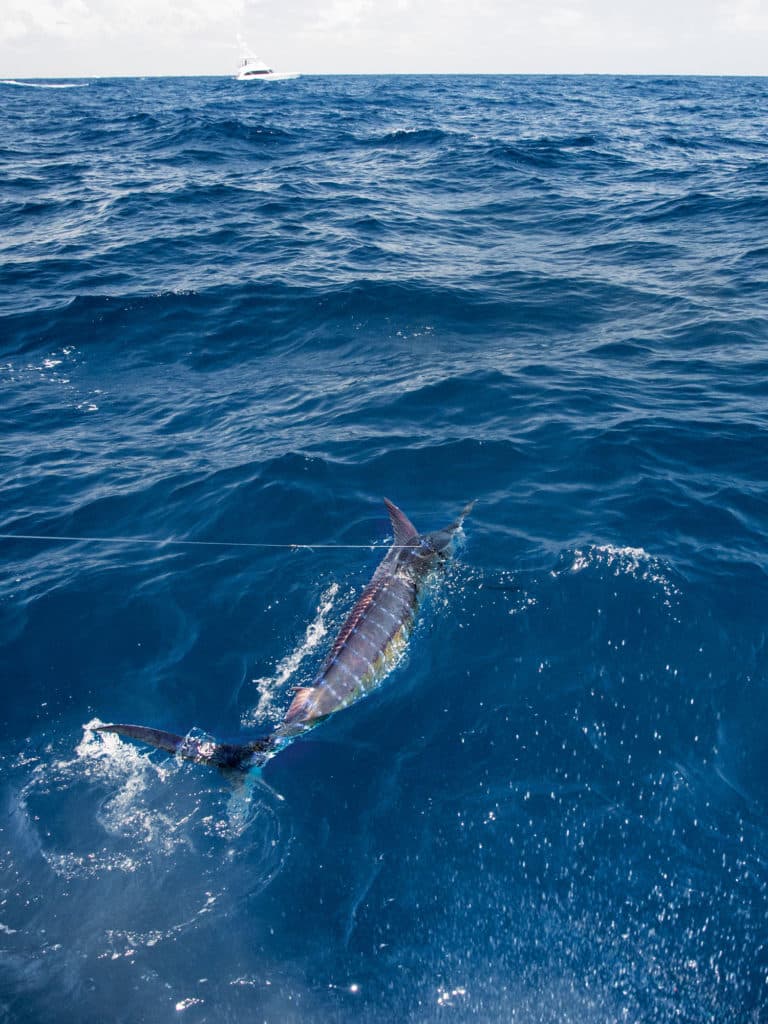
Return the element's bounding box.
[0,77,768,1024]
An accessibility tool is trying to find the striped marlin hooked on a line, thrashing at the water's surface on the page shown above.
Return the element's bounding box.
[96,499,474,771]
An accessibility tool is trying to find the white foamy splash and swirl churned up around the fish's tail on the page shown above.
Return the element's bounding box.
[10,719,283,890]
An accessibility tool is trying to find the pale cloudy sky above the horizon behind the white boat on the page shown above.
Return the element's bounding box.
[0,0,768,78]
